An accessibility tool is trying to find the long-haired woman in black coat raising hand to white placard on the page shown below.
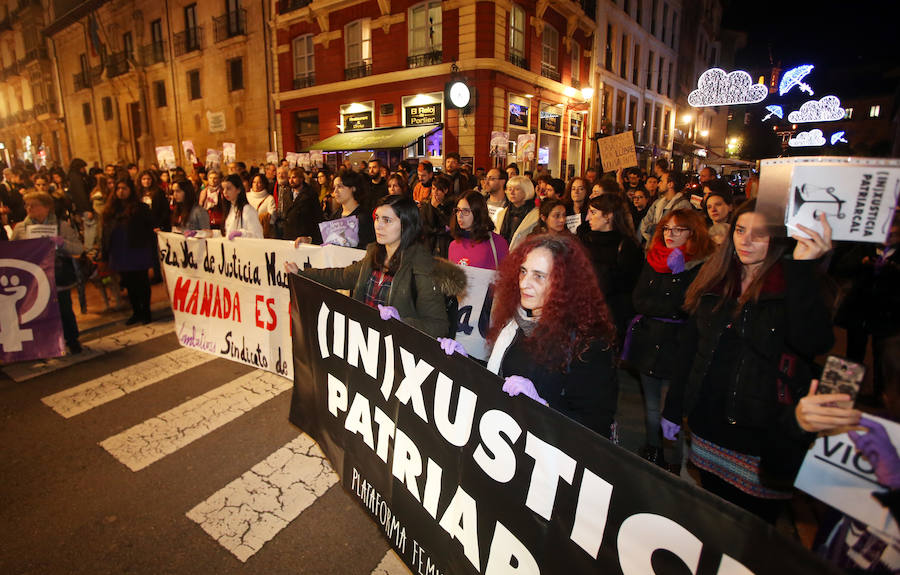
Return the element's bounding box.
[662,200,834,523]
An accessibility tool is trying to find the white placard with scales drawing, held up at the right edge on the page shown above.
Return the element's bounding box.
[758,157,900,244]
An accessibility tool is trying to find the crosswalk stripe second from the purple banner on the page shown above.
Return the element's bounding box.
[41,347,216,419]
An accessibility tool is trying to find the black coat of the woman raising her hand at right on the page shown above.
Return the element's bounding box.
[663,260,834,485]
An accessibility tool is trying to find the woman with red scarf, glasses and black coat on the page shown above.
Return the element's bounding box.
[622,208,715,473]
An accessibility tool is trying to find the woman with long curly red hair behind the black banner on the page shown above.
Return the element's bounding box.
[487,235,619,438]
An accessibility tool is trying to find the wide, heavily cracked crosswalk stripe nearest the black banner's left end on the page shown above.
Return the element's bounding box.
[187,433,338,561]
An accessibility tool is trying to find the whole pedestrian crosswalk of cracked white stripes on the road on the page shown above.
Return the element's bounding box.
[23,322,409,575]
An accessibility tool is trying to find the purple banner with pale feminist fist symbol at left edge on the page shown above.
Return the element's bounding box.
[0,238,65,363]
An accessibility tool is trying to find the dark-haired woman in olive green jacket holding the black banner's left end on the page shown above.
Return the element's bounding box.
[285,195,449,337]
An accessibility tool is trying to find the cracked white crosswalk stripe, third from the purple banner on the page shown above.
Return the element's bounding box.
[100,370,292,471]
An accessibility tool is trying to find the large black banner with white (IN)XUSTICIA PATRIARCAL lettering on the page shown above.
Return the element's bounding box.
[290,275,837,575]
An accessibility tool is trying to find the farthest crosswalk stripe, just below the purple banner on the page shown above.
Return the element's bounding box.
[3,320,175,382]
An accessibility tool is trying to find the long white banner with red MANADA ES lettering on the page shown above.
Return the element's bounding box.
[157,232,365,378]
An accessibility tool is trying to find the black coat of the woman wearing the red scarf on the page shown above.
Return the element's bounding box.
[626,260,703,379]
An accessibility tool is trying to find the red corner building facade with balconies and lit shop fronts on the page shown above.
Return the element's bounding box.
[275,0,596,175]
